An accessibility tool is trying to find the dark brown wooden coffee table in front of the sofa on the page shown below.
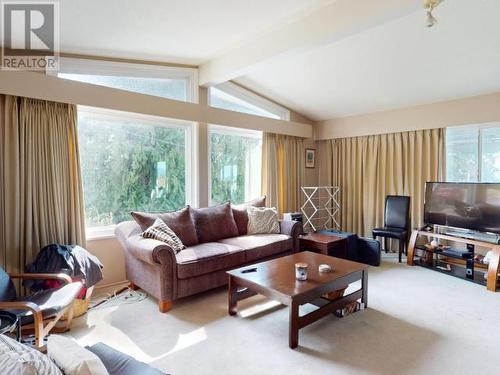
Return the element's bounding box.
[227,251,368,349]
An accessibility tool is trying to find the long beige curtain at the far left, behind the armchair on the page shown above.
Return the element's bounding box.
[0,96,85,272]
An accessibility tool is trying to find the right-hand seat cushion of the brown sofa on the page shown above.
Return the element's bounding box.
[219,234,293,262]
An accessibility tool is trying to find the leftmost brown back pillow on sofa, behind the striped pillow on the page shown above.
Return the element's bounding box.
[131,206,198,246]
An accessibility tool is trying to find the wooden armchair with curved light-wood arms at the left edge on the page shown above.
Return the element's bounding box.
[0,267,82,348]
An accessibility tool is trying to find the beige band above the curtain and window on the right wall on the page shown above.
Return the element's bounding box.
[314,93,500,140]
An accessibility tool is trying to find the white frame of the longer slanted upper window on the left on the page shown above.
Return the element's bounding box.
[47,57,198,103]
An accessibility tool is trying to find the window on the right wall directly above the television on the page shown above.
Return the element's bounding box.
[446,125,500,182]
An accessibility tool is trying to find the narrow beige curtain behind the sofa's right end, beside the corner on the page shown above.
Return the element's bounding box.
[262,133,305,217]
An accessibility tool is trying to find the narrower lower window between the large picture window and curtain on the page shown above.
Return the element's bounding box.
[209,125,262,204]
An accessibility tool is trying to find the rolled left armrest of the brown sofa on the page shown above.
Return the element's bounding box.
[125,234,177,268]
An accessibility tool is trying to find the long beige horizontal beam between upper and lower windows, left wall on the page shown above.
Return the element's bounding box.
[0,70,313,138]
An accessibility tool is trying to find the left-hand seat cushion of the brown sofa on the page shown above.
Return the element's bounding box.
[176,242,245,279]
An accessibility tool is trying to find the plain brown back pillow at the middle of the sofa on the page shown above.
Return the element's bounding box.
[193,202,238,243]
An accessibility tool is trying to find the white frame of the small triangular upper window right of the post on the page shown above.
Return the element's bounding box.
[208,81,290,121]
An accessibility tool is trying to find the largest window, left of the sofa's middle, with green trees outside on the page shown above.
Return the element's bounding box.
[78,107,191,232]
